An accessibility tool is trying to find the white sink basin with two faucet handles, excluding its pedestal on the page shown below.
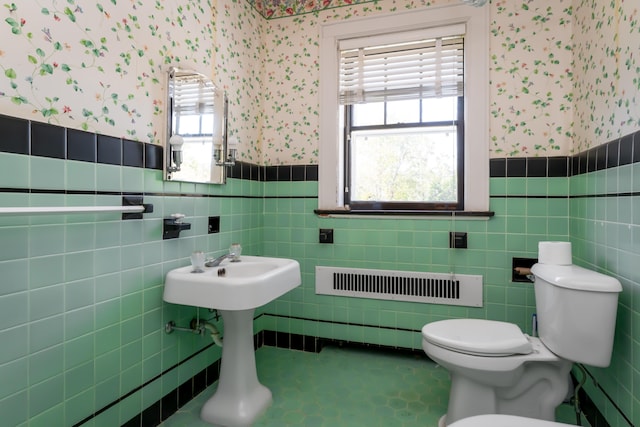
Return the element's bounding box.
[163,256,301,310]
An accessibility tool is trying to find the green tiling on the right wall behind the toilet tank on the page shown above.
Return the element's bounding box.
[570,163,640,427]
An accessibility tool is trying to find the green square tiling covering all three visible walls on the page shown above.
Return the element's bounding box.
[0,146,640,426]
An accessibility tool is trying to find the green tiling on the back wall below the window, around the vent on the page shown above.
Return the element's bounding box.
[263,178,569,349]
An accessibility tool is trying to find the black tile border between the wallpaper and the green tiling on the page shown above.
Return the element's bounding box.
[0,114,640,182]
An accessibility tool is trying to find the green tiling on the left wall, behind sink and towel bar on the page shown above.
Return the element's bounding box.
[0,153,263,426]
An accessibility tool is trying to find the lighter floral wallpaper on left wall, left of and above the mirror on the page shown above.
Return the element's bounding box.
[0,0,214,142]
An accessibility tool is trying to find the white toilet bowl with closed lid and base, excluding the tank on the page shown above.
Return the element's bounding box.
[422,319,572,427]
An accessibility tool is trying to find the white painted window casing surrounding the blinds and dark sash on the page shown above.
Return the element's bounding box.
[318,5,489,212]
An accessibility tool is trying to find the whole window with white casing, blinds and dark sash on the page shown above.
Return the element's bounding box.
[319,6,489,213]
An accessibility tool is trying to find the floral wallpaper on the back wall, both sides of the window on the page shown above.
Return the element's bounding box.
[256,0,573,164]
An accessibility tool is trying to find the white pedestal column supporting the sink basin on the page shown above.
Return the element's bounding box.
[200,309,273,427]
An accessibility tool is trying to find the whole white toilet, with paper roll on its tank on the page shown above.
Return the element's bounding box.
[422,242,622,427]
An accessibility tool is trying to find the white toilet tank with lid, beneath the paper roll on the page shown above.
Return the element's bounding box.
[531,264,622,367]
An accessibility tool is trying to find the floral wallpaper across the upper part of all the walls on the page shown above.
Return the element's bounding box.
[0,0,640,161]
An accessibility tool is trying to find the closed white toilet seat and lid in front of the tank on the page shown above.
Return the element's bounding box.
[422,319,533,357]
